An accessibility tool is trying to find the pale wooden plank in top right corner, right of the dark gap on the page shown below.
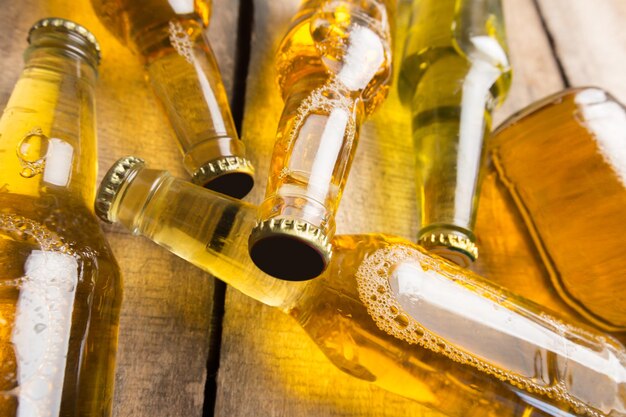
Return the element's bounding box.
[537,0,626,103]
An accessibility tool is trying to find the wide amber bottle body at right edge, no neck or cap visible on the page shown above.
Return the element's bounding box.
[476,88,626,334]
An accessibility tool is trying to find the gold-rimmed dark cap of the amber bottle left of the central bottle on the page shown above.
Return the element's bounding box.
[191,155,254,199]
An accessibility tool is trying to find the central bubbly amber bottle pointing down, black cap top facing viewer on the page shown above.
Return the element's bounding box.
[249,0,395,280]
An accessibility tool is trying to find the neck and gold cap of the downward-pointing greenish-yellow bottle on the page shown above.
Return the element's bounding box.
[413,54,502,266]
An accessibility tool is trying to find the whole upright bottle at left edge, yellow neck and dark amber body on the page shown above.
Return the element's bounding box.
[0,18,122,417]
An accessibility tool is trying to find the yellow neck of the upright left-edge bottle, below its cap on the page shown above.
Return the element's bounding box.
[0,40,97,207]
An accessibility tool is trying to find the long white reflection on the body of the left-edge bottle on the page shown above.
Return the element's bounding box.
[12,250,78,417]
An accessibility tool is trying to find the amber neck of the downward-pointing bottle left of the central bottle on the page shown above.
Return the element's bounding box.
[143,19,246,184]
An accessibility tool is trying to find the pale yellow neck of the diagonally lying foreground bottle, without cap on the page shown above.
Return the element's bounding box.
[108,166,305,308]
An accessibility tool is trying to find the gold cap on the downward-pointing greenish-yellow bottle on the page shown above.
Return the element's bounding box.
[418,231,478,267]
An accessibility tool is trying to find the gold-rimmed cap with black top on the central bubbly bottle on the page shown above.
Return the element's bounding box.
[248,218,332,281]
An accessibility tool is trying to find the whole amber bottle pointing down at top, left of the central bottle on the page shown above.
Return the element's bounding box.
[92,0,254,198]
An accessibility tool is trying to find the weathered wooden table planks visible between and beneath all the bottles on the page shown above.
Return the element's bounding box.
[0,0,626,417]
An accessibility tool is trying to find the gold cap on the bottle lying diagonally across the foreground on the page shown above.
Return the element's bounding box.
[94,156,145,223]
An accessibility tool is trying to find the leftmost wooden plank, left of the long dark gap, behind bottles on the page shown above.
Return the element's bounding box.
[0,0,238,417]
